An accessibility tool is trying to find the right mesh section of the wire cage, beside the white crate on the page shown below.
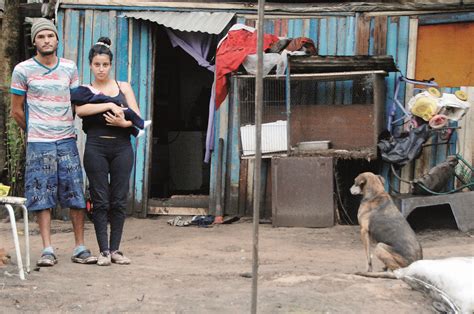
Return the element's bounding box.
[289,74,380,150]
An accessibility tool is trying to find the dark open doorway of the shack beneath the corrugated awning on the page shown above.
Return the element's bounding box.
[149,26,215,202]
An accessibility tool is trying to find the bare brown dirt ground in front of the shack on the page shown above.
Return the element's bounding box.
[0,217,474,313]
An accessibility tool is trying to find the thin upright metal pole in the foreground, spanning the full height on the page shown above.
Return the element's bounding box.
[251,0,265,314]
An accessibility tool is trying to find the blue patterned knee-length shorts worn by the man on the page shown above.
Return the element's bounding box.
[25,138,86,211]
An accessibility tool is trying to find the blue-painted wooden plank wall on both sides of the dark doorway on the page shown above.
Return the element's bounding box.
[58,4,472,214]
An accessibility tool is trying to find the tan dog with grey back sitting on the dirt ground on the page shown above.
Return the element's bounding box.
[351,172,423,277]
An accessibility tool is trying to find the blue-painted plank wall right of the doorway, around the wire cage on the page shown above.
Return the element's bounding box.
[215,14,409,213]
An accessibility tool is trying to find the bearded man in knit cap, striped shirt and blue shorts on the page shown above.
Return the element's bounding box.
[11,18,97,266]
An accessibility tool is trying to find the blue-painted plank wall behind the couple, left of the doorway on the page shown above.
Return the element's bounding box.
[58,8,153,215]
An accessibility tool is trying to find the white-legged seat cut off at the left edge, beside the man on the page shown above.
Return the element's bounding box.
[0,196,30,280]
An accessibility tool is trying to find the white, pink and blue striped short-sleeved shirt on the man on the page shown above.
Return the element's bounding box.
[11,58,79,142]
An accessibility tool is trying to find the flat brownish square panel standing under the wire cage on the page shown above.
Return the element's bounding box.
[272,157,335,227]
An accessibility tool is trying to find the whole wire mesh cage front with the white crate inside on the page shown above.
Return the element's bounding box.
[233,71,385,155]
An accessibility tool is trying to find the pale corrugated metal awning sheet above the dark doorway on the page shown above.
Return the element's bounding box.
[121,12,234,34]
